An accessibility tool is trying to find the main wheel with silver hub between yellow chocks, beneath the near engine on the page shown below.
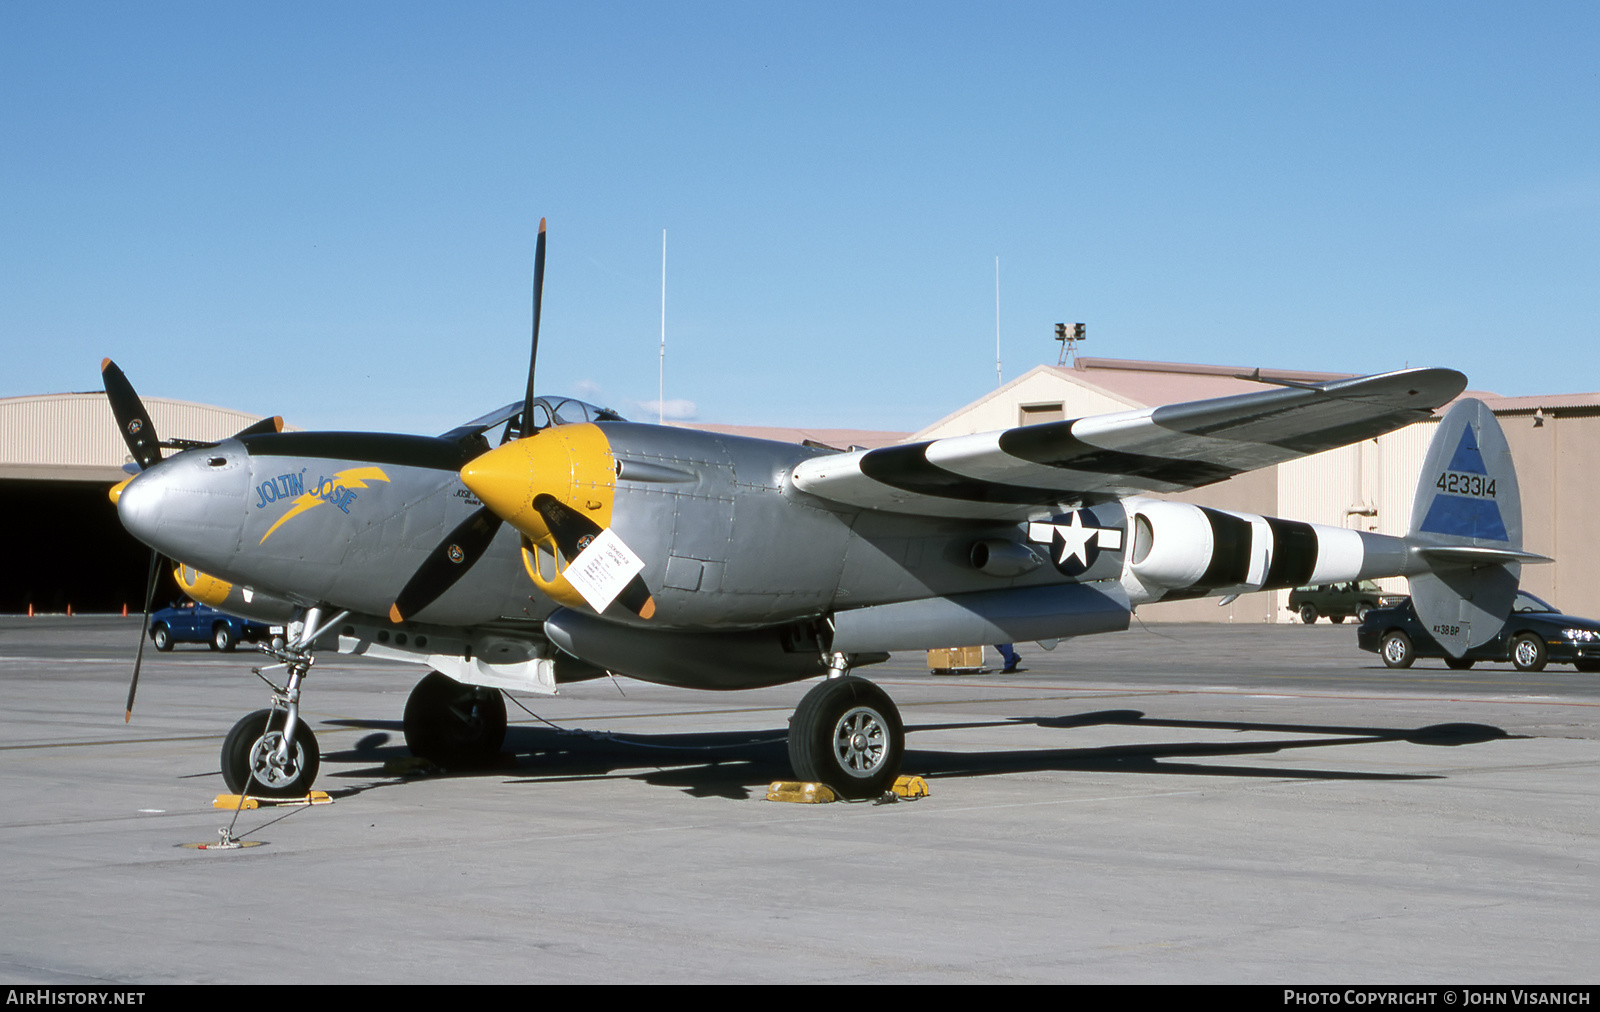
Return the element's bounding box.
[789,676,906,799]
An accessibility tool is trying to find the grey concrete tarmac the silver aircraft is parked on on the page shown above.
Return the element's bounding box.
[0,616,1600,985]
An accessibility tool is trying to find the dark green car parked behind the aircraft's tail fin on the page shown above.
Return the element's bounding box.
[1355,591,1600,671]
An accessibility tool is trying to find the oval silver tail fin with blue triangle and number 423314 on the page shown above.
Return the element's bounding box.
[1406,397,1549,657]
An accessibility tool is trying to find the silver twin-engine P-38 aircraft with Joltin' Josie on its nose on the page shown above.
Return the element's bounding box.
[102,221,1542,797]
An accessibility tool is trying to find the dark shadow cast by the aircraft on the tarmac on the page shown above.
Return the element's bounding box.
[323,709,1518,801]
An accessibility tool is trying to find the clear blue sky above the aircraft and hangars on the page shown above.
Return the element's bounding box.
[0,2,1600,432]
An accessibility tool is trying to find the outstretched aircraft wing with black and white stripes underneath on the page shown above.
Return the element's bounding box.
[794,368,1467,520]
